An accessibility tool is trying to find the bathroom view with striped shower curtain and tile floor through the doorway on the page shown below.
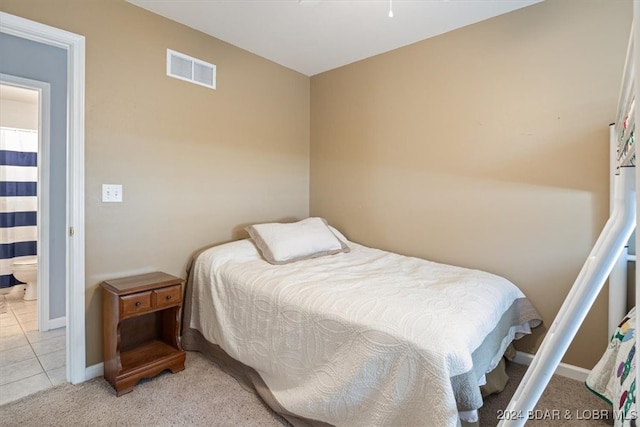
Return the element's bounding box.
[0,83,66,404]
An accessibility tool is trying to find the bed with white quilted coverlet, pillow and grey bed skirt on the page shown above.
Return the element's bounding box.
[182,218,541,427]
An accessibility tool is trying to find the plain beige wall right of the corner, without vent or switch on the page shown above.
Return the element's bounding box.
[310,0,632,369]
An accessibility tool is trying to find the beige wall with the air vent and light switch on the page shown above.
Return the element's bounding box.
[2,0,310,366]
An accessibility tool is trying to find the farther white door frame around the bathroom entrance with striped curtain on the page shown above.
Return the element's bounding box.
[0,73,51,331]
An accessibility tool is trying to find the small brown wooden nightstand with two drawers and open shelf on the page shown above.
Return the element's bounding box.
[100,272,185,396]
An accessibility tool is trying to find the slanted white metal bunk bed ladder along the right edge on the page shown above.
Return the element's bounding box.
[498,14,640,427]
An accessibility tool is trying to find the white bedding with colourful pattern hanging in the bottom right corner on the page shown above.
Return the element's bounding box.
[585,307,637,427]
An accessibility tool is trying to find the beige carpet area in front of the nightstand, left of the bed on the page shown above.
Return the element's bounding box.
[0,352,288,427]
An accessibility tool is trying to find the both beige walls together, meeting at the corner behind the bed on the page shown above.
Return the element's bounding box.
[1,0,631,368]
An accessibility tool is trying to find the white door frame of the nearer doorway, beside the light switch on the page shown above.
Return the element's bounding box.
[0,12,87,384]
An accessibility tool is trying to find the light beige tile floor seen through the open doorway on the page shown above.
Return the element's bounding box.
[0,292,66,405]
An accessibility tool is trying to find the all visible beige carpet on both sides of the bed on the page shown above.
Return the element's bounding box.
[0,352,613,427]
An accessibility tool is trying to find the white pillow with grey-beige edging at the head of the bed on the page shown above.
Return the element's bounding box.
[245,217,349,265]
